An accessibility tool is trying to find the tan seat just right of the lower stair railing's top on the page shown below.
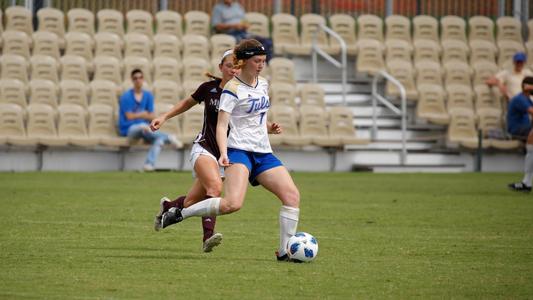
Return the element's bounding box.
[416,84,450,125]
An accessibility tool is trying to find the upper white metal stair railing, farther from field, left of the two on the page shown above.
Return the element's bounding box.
[311,24,347,105]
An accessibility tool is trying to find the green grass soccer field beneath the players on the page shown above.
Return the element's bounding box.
[0,173,533,299]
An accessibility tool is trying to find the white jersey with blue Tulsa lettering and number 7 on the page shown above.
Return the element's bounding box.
[219,77,272,153]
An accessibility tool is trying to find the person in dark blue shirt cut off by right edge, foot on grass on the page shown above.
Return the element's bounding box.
[507,77,533,192]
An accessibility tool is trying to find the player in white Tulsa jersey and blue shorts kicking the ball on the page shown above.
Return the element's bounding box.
[161,39,300,261]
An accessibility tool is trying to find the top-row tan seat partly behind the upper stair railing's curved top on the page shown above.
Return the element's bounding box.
[329,14,357,55]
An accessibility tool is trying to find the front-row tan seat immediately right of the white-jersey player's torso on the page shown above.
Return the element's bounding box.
[268,103,311,146]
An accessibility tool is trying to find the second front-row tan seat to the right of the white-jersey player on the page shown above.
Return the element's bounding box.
[300,105,342,147]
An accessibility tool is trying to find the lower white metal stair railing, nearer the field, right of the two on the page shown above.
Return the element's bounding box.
[371,71,407,165]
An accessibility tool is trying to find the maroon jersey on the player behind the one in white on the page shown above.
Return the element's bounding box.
[191,79,222,159]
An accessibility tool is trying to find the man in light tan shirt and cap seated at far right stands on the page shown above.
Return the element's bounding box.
[486,52,533,100]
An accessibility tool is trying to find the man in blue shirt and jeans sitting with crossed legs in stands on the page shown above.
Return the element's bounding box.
[118,69,183,171]
